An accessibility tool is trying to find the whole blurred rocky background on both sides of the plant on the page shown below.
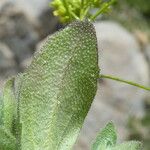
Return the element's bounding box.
[0,0,150,150]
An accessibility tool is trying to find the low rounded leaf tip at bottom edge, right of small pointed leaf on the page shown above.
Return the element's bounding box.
[111,141,142,150]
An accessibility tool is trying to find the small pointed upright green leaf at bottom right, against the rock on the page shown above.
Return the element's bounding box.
[92,123,117,150]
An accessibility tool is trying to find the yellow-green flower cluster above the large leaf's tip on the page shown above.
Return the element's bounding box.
[50,0,114,23]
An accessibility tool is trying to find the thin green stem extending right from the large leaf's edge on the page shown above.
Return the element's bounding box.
[100,74,150,91]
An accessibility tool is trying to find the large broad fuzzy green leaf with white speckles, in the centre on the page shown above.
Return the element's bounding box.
[18,21,99,150]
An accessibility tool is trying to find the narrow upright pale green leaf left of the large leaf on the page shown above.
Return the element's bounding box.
[2,78,17,131]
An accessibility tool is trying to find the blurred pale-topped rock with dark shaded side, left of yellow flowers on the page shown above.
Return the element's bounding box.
[14,0,58,38]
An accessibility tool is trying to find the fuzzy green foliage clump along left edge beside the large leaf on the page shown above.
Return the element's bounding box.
[0,78,16,150]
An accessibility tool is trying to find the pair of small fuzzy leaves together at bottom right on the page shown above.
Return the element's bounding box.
[92,123,142,150]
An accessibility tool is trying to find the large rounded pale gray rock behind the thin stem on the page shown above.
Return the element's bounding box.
[74,21,149,150]
